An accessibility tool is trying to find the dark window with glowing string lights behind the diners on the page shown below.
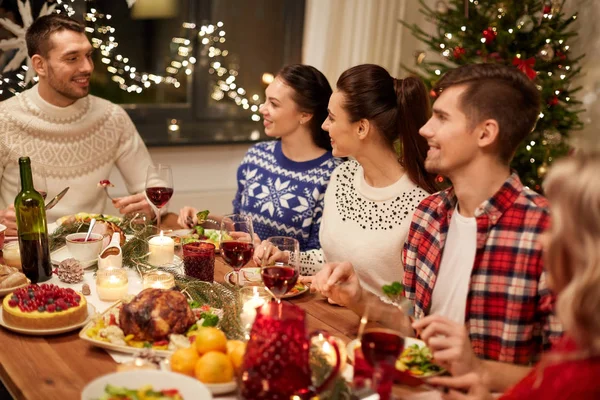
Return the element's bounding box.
[0,0,305,146]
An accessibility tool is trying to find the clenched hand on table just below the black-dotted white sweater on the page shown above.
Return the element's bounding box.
[300,261,363,307]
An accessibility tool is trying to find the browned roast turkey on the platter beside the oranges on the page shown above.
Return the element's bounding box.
[119,289,196,341]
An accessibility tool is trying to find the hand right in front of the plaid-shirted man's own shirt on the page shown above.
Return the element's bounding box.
[412,315,482,376]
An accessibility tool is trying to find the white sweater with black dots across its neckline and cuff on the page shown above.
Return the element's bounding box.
[300,160,429,296]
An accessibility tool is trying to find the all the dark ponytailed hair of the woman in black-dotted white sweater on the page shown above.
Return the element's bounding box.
[337,64,437,193]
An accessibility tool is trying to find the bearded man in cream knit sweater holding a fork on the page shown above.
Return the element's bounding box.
[0,14,159,235]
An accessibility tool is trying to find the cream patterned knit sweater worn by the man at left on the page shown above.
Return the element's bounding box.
[0,86,157,221]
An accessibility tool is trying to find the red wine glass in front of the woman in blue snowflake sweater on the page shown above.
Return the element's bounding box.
[219,214,254,285]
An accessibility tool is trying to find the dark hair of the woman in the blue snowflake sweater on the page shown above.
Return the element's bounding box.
[277,64,333,151]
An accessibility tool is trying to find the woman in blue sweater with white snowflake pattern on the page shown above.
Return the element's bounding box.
[179,64,341,251]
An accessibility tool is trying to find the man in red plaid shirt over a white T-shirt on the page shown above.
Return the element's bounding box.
[313,64,562,390]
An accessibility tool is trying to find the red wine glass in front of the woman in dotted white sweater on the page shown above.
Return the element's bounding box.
[260,236,300,303]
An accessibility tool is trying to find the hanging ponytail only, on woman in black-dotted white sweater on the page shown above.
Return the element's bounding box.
[394,76,437,193]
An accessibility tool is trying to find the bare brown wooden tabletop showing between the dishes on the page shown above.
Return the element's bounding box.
[0,216,434,400]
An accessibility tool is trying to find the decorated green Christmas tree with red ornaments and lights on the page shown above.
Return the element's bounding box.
[401,0,583,191]
